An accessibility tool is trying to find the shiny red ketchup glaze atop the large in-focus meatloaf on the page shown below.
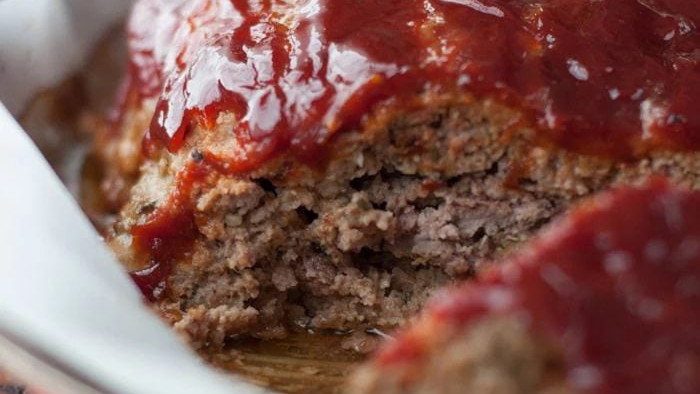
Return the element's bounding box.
[124,0,700,300]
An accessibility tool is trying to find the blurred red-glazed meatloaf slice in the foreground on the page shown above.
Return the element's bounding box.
[349,180,700,394]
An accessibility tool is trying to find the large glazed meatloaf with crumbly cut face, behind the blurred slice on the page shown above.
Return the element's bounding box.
[96,0,700,346]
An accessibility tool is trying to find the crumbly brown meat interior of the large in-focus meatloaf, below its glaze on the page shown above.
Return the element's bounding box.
[98,90,700,346]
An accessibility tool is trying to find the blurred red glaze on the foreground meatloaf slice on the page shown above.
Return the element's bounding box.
[378,182,700,394]
